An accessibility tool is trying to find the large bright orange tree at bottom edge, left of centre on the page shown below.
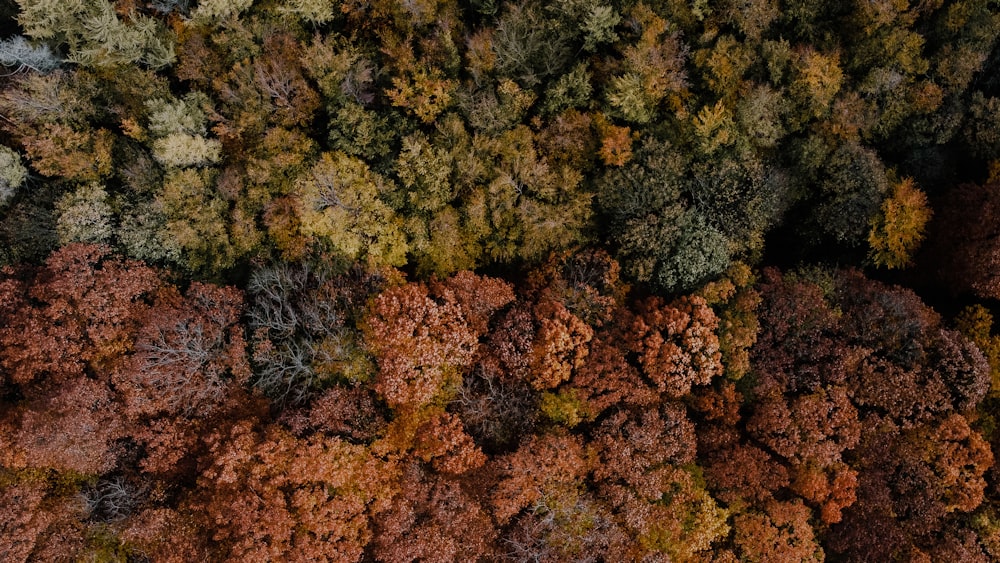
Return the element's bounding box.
[188,420,394,562]
